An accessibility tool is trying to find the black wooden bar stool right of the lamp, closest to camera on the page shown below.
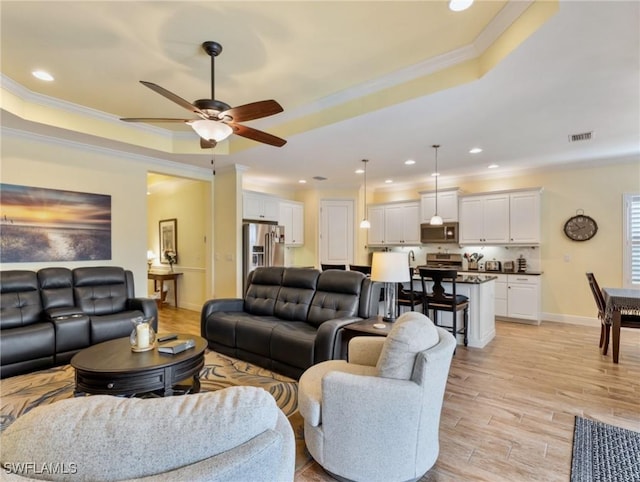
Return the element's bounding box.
[419,268,469,346]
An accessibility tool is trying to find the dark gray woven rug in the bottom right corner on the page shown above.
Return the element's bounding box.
[571,417,640,482]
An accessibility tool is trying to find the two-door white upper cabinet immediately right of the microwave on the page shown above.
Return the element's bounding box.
[459,193,509,244]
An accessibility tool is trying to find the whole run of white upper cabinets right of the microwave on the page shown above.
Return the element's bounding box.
[460,189,541,246]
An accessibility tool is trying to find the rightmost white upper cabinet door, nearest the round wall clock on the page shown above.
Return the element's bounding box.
[509,189,541,245]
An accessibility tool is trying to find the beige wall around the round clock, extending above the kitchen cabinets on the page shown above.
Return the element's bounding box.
[372,159,640,323]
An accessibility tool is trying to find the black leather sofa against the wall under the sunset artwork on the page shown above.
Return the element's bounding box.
[0,266,158,378]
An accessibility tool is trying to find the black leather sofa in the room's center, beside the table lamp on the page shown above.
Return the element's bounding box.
[200,267,380,379]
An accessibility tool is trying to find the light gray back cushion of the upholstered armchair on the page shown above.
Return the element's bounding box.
[376,311,440,380]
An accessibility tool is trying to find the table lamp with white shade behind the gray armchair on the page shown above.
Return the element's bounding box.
[371,251,409,321]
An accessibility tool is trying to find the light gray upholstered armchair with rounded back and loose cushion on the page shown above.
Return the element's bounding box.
[298,312,456,482]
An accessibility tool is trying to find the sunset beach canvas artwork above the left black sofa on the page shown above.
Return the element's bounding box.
[0,184,111,263]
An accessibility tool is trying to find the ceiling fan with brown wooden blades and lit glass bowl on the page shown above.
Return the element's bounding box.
[120,41,287,149]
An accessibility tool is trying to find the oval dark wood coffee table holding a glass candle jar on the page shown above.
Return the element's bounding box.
[71,335,207,397]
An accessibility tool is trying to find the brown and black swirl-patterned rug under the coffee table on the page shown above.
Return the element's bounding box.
[0,351,311,470]
